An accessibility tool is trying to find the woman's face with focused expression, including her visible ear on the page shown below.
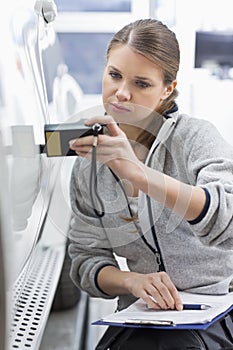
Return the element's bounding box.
[102,45,176,124]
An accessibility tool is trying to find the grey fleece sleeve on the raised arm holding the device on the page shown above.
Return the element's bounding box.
[183,121,233,248]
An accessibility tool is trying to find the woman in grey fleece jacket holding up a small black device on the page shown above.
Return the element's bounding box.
[69,19,233,350]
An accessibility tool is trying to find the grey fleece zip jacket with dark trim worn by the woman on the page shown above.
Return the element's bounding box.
[69,110,233,309]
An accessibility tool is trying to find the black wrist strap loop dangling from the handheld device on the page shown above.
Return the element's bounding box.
[90,123,105,218]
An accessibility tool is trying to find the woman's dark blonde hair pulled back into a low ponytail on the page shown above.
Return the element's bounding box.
[107,18,180,114]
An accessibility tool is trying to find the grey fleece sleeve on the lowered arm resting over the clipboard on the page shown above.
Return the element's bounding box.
[69,159,119,299]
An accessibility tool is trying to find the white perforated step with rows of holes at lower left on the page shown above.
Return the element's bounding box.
[10,247,64,350]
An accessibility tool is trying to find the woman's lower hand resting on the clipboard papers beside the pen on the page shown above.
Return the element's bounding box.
[124,272,183,310]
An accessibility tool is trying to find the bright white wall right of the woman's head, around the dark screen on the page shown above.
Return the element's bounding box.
[175,0,233,144]
